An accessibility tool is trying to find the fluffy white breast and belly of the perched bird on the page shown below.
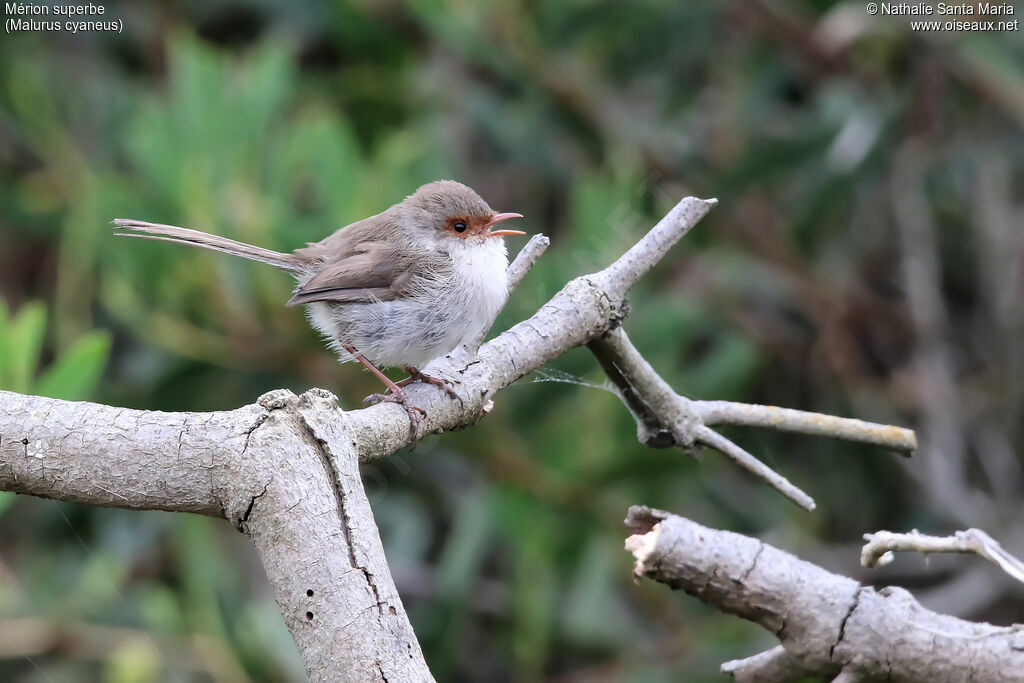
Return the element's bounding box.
[308,239,508,368]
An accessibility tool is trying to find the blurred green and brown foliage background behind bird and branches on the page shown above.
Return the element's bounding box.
[0,0,1024,683]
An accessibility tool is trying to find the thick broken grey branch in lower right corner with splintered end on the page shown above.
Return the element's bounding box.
[626,507,1024,683]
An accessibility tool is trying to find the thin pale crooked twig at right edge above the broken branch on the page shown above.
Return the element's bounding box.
[860,528,1024,582]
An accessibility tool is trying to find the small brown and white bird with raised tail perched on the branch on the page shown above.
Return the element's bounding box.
[112,180,525,434]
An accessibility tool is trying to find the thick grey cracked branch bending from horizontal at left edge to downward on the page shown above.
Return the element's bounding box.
[0,390,430,681]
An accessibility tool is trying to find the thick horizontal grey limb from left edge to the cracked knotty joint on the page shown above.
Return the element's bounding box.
[0,391,245,516]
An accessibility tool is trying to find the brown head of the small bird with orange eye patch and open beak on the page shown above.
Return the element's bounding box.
[401,180,525,241]
